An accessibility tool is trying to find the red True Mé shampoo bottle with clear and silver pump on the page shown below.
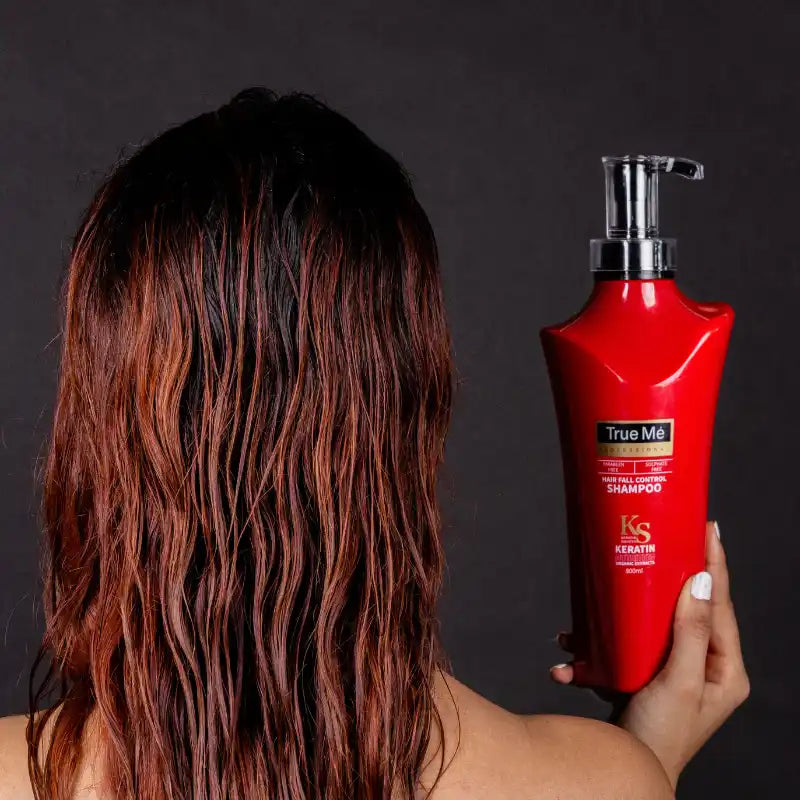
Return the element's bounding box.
[541,156,733,692]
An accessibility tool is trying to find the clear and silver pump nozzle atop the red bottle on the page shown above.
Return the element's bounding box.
[590,156,703,278]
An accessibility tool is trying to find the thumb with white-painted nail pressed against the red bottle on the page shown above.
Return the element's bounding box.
[663,572,712,692]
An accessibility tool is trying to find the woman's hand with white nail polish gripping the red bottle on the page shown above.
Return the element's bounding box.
[550,523,750,788]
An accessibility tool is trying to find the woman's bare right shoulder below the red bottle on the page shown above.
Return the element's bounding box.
[423,676,674,800]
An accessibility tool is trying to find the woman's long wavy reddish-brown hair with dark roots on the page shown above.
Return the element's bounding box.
[28,89,452,800]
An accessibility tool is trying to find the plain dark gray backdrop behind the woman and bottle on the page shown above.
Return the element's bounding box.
[0,0,800,798]
